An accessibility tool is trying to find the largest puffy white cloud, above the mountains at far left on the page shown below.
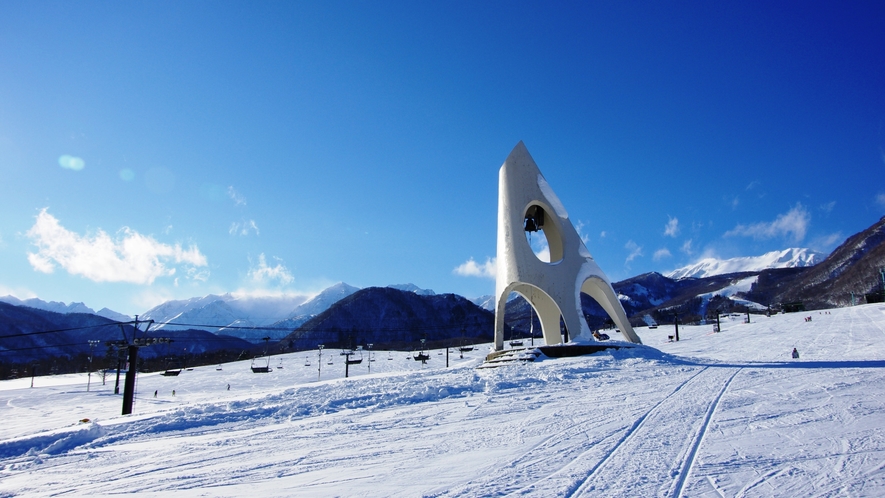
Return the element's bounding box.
[26,208,208,284]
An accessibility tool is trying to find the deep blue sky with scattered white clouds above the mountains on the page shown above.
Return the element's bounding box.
[0,1,885,314]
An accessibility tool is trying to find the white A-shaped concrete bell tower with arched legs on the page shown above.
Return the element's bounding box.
[495,142,641,351]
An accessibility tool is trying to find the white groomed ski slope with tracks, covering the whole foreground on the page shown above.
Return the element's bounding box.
[0,304,885,498]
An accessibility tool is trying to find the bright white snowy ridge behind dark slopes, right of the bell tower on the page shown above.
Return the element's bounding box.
[664,247,826,280]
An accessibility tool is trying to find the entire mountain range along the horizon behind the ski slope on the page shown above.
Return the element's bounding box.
[6,217,885,366]
